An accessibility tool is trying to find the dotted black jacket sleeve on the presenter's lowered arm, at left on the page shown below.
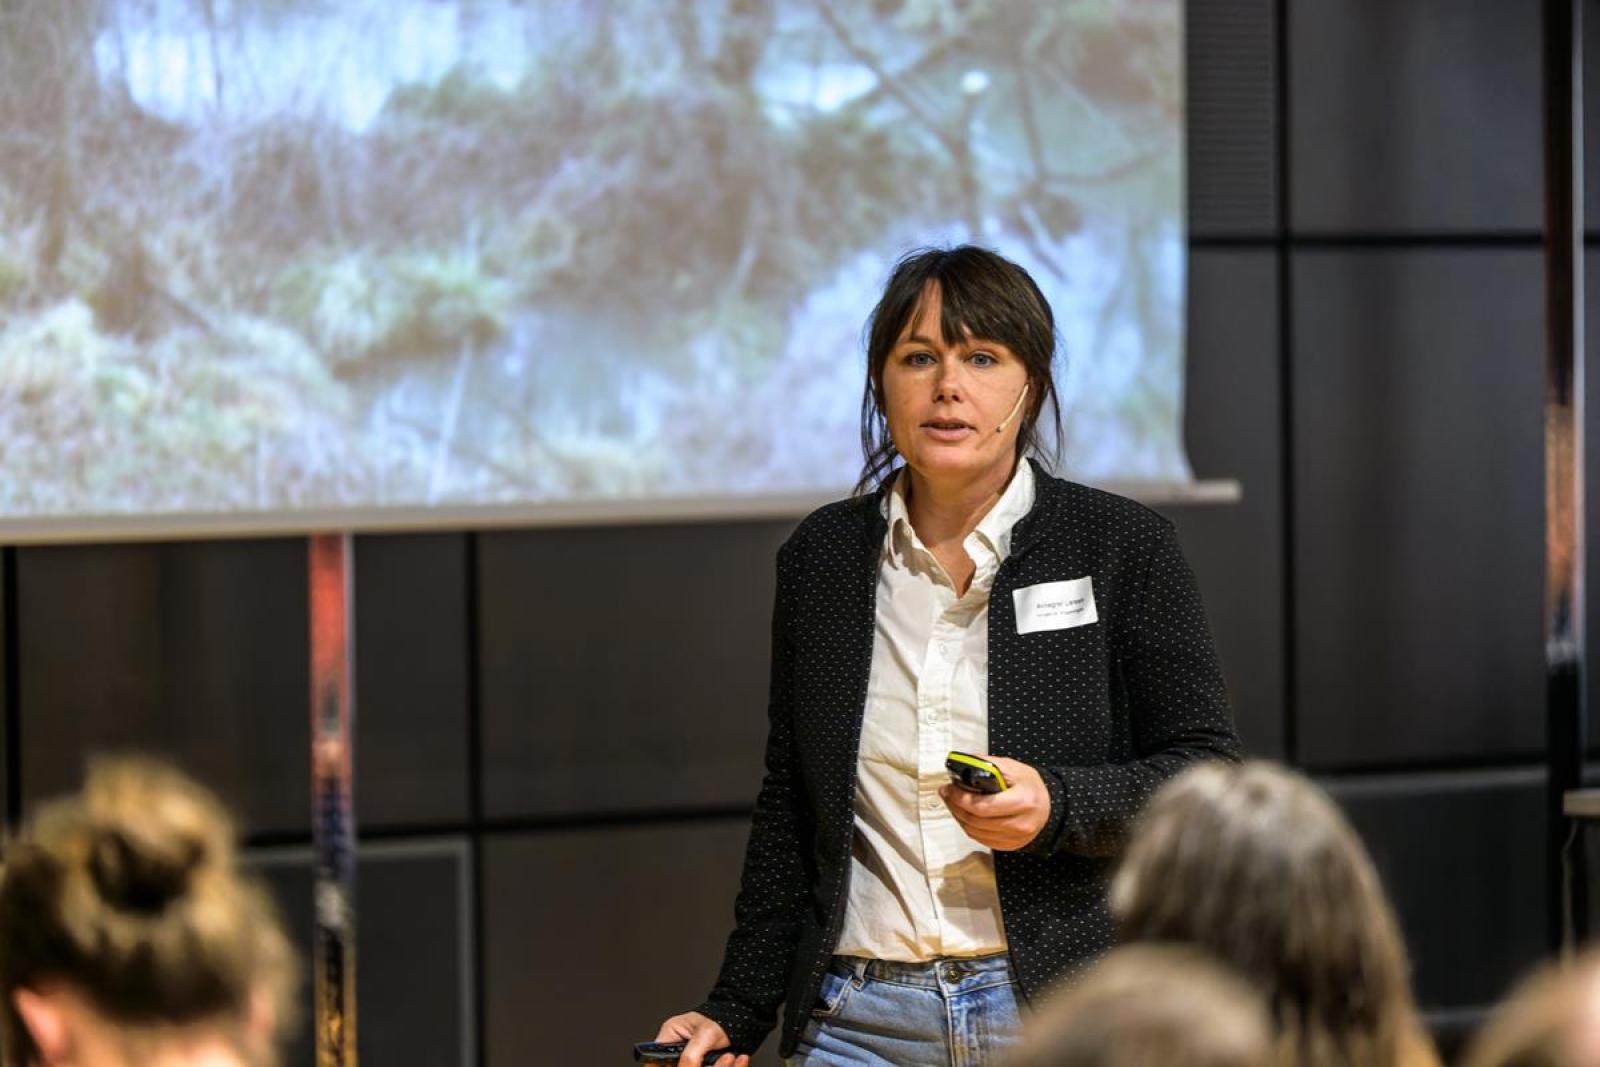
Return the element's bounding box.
[696,542,813,1051]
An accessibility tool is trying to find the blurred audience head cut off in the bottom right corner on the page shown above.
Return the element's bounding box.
[1466,950,1600,1067]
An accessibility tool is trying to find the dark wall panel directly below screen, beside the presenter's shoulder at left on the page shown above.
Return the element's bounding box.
[478,522,794,816]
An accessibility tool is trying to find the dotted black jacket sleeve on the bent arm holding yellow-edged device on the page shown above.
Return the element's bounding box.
[1022,520,1240,856]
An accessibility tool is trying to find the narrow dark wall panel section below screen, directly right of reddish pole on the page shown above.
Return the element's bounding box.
[355,534,470,827]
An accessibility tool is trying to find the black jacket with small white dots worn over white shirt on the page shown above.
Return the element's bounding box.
[698,460,1238,1056]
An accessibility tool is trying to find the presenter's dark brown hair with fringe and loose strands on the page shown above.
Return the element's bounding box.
[854,245,1061,496]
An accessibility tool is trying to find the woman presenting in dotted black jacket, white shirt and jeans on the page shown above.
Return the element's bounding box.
[658,246,1238,1067]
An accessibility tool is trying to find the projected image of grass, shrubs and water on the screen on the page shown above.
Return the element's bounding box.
[0,0,1187,517]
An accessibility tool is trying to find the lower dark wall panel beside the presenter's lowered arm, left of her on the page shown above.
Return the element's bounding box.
[483,819,779,1067]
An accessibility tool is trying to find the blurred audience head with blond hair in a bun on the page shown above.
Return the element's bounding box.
[0,758,294,1067]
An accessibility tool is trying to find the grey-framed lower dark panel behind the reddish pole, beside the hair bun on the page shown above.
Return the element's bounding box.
[246,838,467,1067]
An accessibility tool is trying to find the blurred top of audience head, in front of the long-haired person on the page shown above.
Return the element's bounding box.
[1006,944,1275,1067]
